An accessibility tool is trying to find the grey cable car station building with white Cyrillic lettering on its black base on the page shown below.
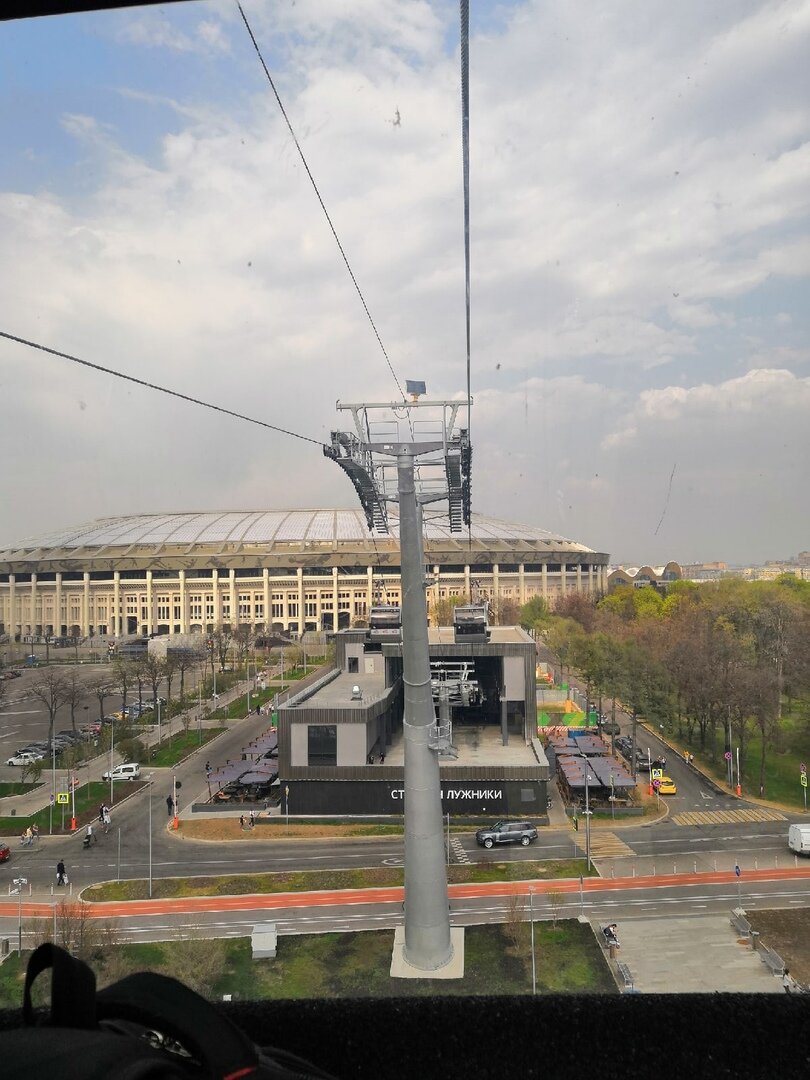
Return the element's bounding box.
[279,609,550,816]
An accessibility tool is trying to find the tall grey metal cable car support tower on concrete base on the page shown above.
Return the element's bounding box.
[324,400,471,978]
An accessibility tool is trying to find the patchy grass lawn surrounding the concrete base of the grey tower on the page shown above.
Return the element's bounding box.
[0,913,618,1008]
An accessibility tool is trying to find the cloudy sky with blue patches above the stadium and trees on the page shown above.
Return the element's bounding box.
[0,0,810,565]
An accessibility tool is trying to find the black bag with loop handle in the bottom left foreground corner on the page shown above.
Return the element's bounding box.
[0,943,333,1080]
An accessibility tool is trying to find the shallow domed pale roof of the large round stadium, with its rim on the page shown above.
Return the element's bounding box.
[0,508,608,575]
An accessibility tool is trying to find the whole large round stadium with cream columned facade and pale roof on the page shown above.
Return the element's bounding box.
[0,510,608,637]
